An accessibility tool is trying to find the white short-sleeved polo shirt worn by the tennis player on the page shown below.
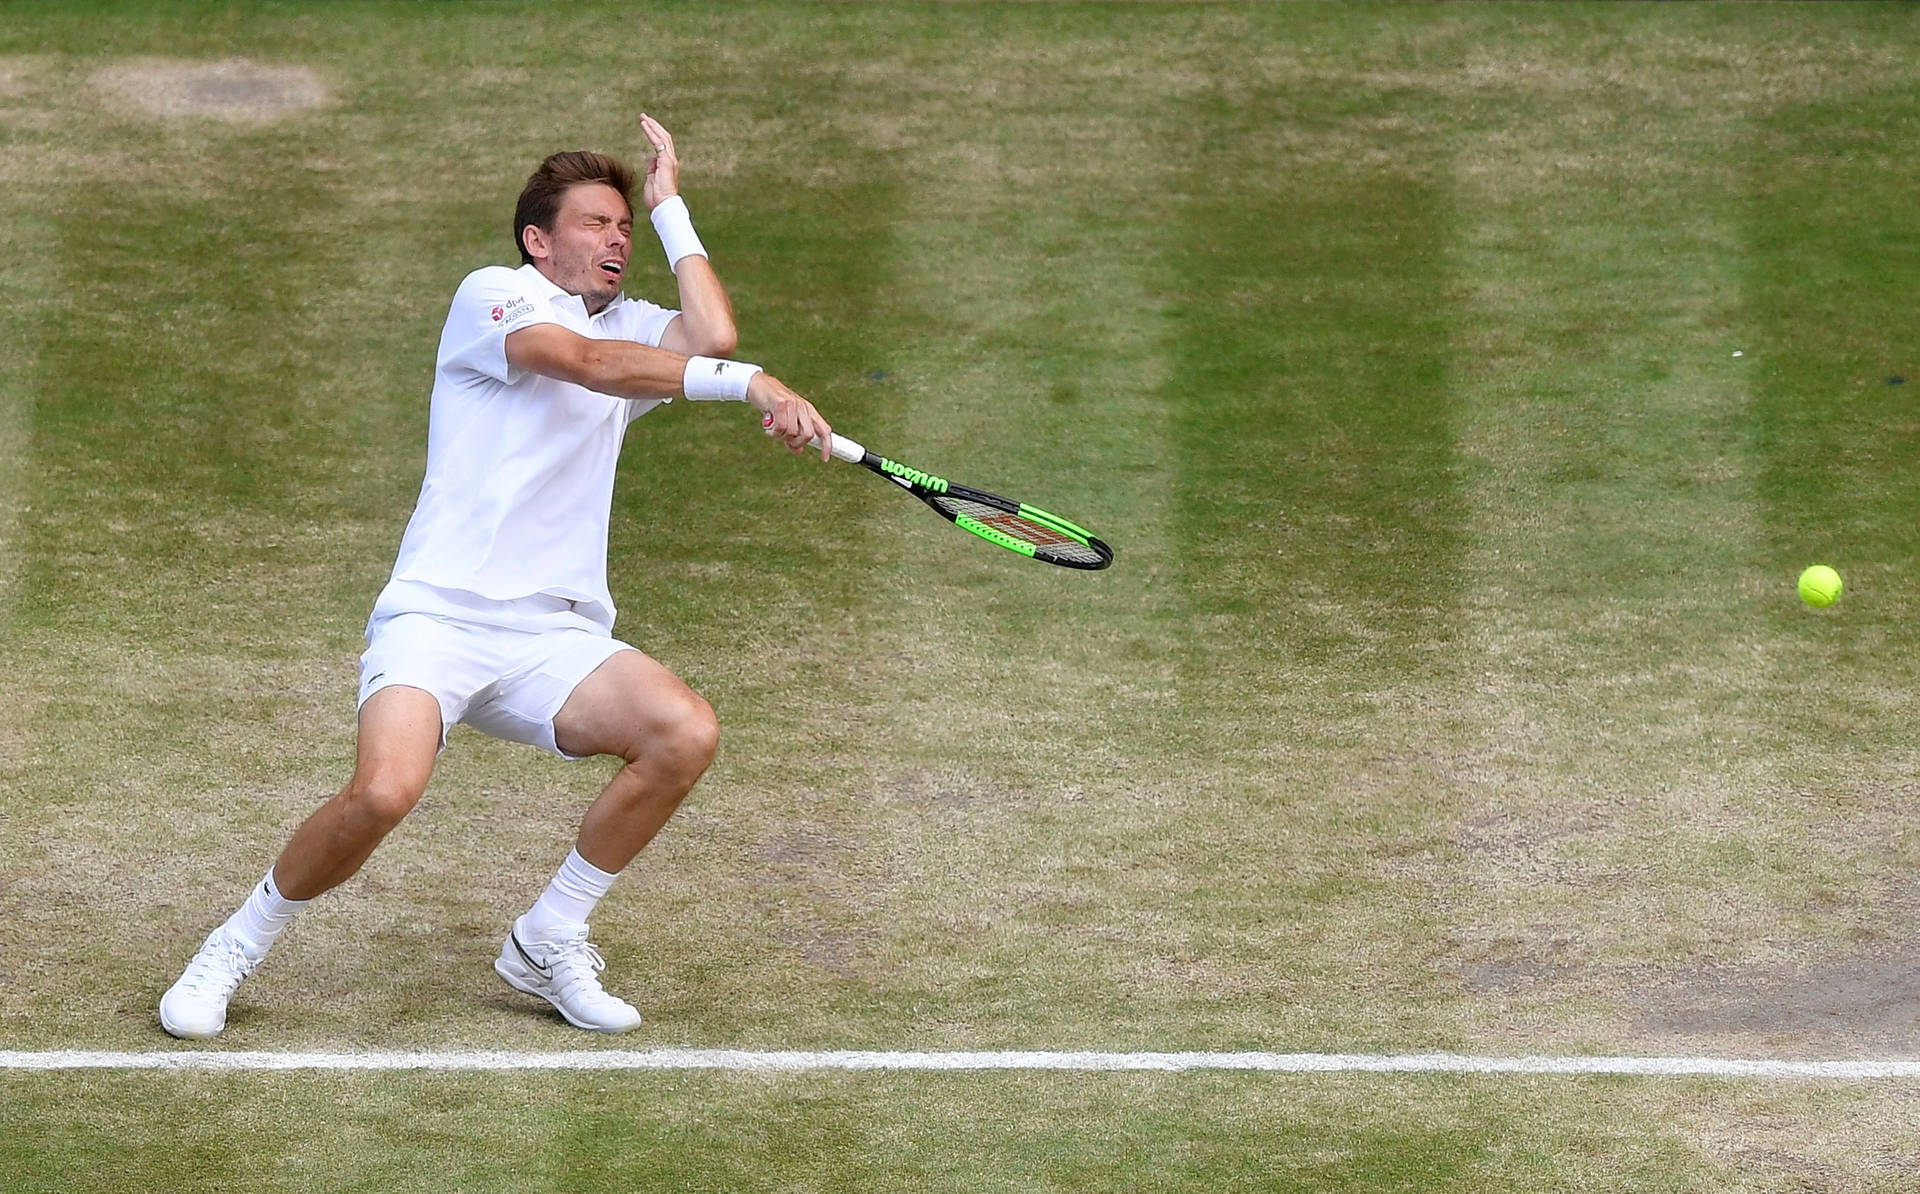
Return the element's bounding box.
[374,265,678,632]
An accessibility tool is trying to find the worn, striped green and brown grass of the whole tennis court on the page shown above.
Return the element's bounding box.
[0,4,1920,1190]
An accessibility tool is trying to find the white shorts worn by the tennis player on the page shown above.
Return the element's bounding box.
[359,597,634,758]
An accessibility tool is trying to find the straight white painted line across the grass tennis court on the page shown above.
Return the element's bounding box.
[0,1048,1920,1079]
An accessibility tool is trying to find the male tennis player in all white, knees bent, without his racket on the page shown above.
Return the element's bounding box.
[159,115,831,1037]
